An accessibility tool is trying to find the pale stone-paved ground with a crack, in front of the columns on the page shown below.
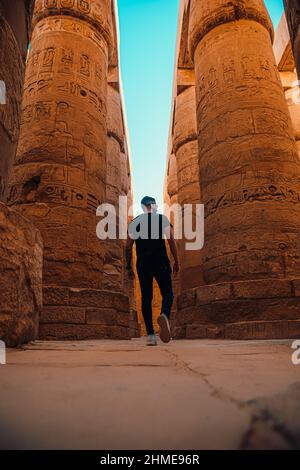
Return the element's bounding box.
[0,338,300,450]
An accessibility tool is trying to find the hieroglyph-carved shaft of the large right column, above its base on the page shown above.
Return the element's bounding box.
[190,0,300,290]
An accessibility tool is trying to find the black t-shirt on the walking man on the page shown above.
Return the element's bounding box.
[128,212,172,264]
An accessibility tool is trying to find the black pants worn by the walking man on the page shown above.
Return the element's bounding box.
[137,261,174,335]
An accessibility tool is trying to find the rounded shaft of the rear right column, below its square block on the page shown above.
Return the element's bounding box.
[173,86,203,291]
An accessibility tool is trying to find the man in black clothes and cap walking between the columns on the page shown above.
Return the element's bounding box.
[126,196,179,346]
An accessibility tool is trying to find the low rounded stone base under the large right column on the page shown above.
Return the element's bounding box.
[173,279,300,340]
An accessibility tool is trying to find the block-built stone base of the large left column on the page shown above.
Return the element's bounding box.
[39,286,138,341]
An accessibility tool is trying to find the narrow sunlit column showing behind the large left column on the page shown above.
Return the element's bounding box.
[105,6,140,337]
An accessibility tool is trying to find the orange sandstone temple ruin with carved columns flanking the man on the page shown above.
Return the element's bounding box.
[0,0,300,346]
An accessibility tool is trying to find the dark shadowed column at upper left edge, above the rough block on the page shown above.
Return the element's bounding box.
[0,0,33,201]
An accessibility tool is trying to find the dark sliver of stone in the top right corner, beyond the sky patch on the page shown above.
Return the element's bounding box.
[284,0,300,80]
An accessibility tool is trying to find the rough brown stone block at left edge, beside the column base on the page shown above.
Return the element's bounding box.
[0,203,43,347]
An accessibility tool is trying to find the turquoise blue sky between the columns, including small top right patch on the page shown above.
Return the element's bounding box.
[118,0,283,209]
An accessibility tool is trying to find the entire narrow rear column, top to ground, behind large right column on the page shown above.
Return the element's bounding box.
[165,0,203,338]
